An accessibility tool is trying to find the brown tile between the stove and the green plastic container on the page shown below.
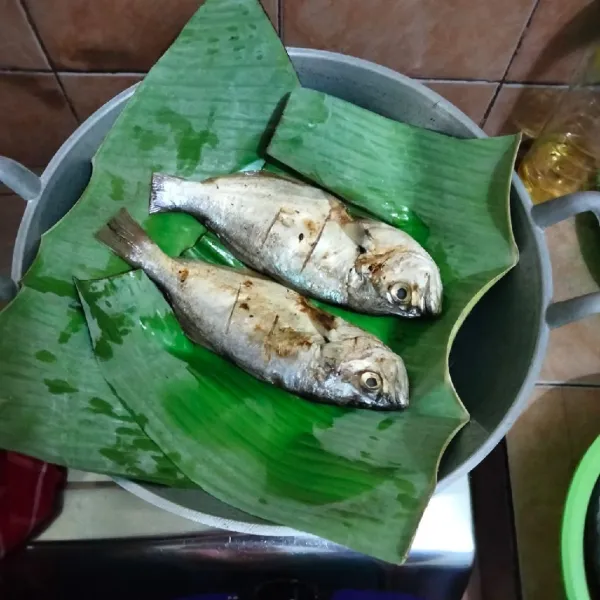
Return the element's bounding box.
[507,387,600,600]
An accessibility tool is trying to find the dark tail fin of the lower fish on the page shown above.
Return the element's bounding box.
[95,208,158,267]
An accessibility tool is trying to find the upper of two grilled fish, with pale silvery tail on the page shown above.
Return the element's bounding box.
[150,171,442,317]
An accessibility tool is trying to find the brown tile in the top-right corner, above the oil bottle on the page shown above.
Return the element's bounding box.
[507,0,600,83]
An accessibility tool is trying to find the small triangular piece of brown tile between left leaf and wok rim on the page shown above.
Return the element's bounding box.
[59,73,143,121]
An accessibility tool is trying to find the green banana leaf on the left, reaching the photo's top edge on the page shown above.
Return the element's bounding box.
[0,0,298,485]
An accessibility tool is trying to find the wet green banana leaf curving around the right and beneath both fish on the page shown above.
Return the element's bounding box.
[78,106,518,562]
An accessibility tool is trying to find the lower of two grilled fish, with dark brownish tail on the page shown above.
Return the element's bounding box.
[96,209,408,410]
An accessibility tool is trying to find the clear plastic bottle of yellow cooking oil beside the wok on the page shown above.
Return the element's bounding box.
[519,46,600,204]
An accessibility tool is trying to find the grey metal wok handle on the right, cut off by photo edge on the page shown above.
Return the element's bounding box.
[531,192,600,328]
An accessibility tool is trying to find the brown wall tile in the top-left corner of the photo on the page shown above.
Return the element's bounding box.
[0,0,50,70]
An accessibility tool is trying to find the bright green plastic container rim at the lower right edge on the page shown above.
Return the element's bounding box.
[561,437,600,600]
